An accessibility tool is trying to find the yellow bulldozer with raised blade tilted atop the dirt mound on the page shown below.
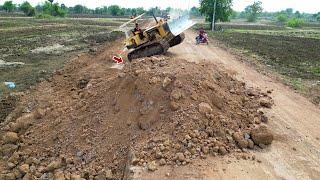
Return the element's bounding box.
[120,14,193,61]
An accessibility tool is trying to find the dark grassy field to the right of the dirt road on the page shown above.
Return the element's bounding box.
[212,33,320,80]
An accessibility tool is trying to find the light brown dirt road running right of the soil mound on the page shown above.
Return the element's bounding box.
[136,31,320,179]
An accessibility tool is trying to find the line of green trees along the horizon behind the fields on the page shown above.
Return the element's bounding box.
[0,0,320,26]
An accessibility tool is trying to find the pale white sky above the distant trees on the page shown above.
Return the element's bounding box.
[4,0,320,13]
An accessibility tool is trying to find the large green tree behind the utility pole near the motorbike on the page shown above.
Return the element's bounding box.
[199,0,232,27]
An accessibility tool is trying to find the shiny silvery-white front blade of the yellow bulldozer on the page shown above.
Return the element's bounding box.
[168,15,195,36]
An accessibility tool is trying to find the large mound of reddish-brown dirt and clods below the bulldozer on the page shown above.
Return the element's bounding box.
[0,48,273,179]
